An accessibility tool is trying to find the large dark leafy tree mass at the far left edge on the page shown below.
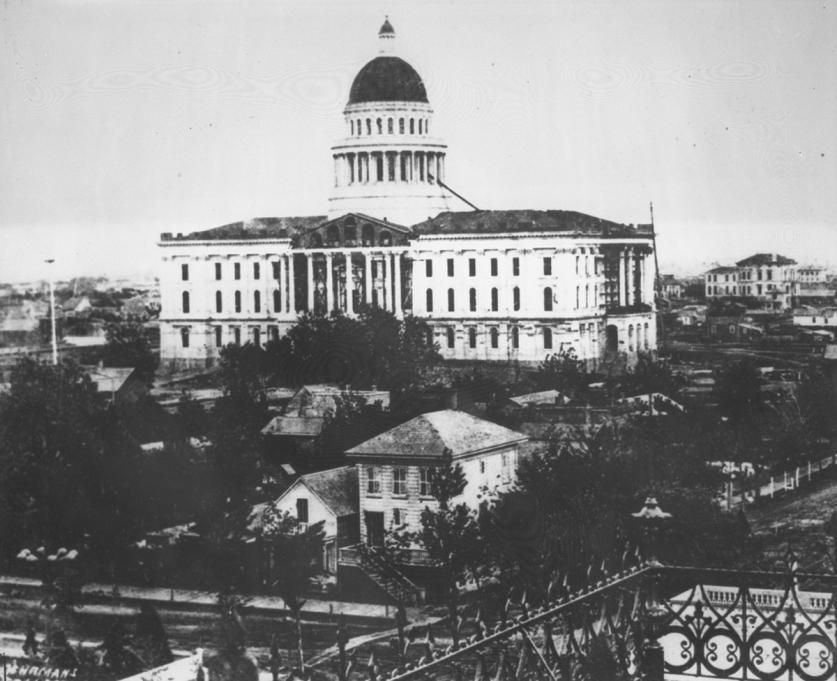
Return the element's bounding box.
[0,359,141,560]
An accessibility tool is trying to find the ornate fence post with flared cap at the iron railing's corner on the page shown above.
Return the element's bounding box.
[631,497,671,681]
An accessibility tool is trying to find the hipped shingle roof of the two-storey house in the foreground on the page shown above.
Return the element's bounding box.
[346,409,528,459]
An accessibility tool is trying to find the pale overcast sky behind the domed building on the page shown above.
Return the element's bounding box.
[0,0,837,280]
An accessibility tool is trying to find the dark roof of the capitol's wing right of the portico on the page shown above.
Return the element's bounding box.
[412,210,651,237]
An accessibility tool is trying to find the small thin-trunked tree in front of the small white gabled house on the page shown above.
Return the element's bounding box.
[253,504,324,673]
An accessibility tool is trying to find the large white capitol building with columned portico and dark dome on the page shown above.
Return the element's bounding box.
[159,20,656,367]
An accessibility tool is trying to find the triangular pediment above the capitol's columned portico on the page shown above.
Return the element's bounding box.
[294,213,412,248]
